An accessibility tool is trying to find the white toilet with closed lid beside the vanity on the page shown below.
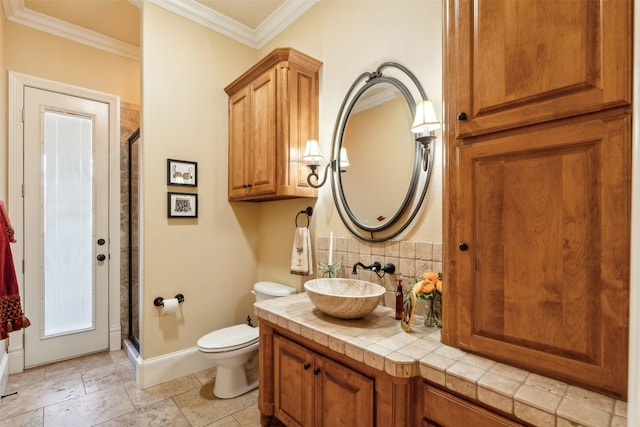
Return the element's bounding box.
[197,282,298,399]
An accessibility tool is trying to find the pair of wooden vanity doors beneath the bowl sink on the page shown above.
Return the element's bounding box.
[274,336,374,427]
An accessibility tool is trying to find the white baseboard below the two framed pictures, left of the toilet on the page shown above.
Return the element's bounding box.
[124,340,215,389]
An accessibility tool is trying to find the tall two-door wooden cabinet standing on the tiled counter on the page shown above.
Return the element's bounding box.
[442,0,633,398]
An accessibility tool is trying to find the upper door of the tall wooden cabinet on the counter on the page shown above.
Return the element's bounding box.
[446,0,633,138]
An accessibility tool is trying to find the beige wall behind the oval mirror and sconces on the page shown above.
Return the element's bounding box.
[252,0,442,288]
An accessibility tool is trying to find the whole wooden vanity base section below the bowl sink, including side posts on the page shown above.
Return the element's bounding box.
[258,318,418,427]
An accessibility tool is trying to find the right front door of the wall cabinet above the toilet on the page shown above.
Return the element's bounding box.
[246,69,277,195]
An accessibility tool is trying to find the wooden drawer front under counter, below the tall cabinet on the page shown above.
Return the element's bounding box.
[422,384,522,427]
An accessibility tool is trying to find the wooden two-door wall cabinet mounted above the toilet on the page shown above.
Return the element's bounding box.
[225,48,322,201]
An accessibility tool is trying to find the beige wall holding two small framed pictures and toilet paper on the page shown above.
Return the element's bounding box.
[141,3,259,359]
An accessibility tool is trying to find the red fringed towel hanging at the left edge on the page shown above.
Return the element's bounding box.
[0,202,31,339]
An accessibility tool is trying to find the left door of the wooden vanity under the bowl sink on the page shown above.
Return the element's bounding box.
[273,335,314,426]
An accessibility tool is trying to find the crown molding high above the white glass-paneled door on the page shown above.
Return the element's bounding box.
[2,0,140,61]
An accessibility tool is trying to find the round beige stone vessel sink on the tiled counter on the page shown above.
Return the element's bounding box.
[304,278,385,319]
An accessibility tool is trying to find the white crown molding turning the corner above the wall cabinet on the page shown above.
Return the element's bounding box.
[144,0,318,49]
